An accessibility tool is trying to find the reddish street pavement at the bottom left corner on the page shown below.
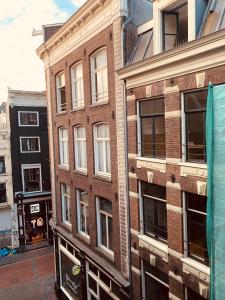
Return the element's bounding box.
[0,248,57,300]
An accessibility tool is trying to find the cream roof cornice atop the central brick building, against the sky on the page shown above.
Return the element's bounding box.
[36,0,127,59]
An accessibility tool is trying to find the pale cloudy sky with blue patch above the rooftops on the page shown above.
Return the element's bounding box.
[0,0,85,102]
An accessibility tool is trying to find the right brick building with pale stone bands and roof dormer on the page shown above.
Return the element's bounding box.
[119,0,225,300]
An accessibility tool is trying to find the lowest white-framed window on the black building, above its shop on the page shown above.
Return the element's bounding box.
[21,164,42,193]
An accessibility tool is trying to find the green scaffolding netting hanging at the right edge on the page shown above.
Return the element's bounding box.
[206,84,225,300]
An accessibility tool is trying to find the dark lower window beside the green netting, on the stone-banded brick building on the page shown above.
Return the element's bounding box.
[185,193,208,264]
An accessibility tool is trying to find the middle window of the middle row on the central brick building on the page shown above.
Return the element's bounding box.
[74,126,87,172]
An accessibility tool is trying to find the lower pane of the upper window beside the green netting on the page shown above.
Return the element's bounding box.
[186,112,206,161]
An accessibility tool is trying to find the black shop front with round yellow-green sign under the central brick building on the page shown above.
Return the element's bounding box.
[55,235,128,300]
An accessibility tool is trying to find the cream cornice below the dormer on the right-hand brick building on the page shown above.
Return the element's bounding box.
[117,29,225,85]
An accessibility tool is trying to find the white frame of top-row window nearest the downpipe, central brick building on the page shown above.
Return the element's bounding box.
[91,47,109,104]
